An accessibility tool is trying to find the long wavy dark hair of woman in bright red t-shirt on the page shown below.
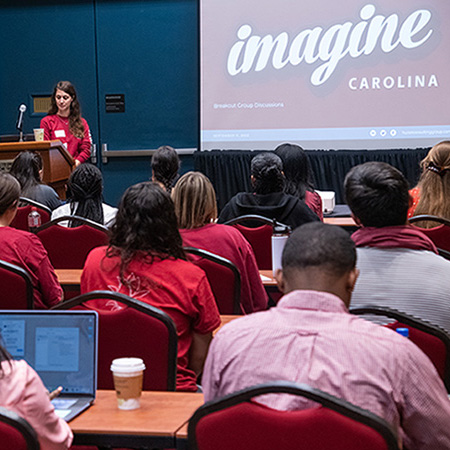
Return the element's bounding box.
[107,181,186,282]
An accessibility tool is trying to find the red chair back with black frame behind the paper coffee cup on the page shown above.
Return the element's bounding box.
[52,291,178,391]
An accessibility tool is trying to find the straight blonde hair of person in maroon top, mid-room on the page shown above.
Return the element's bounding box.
[172,172,217,229]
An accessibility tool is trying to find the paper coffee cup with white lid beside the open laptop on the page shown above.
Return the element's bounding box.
[111,358,145,409]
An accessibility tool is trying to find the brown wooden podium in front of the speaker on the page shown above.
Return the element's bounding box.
[0,141,75,200]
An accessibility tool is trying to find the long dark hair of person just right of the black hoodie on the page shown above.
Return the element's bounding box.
[275,144,314,200]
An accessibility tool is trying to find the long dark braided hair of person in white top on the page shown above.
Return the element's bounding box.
[67,163,104,227]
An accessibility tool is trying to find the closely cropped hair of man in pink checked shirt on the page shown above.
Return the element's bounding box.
[281,222,356,276]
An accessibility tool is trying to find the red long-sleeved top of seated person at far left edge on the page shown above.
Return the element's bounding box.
[0,227,62,309]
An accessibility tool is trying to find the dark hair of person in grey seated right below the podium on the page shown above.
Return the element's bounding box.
[9,152,42,197]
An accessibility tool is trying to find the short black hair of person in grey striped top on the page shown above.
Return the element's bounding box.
[344,162,409,228]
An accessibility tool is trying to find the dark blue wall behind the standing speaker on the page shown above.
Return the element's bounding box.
[0,0,198,204]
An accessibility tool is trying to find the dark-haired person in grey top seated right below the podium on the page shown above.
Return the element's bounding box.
[9,152,61,210]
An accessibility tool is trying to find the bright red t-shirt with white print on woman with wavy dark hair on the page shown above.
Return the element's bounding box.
[81,247,220,391]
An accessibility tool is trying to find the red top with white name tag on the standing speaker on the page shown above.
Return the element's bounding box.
[41,114,92,162]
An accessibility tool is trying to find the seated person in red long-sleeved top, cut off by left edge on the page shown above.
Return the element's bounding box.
[0,173,62,309]
